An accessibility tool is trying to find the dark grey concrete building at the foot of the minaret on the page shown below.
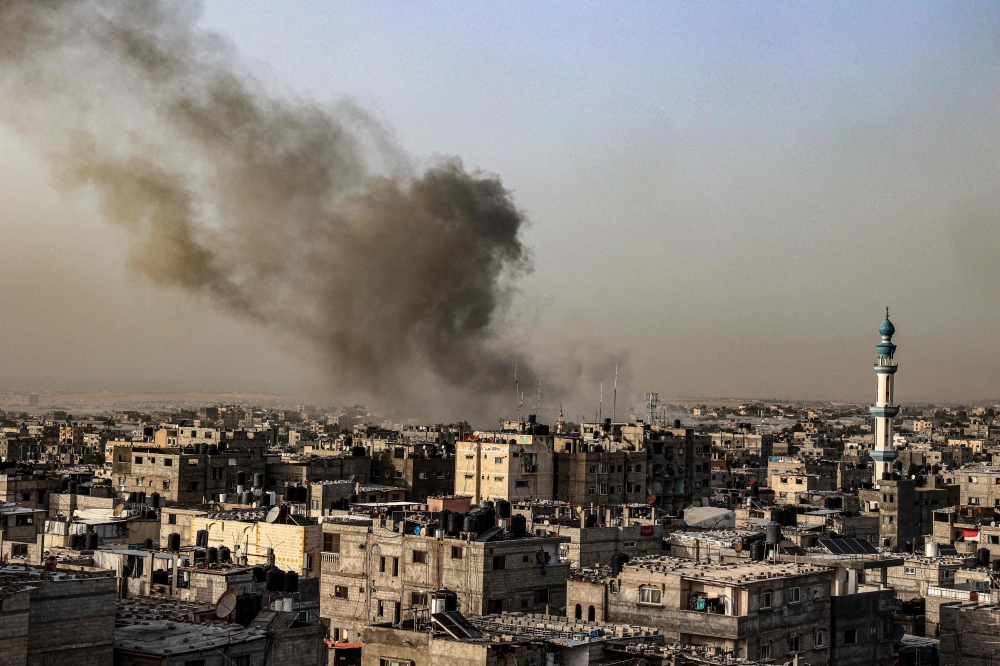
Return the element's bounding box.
[858,479,959,552]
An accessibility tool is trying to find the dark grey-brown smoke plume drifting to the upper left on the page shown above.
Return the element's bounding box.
[0,0,530,416]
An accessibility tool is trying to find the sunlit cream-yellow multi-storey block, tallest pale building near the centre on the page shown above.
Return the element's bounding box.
[454,415,554,503]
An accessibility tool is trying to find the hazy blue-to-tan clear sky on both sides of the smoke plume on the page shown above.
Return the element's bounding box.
[0,0,1000,411]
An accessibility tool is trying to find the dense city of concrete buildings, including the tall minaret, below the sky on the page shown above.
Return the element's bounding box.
[0,317,1000,666]
